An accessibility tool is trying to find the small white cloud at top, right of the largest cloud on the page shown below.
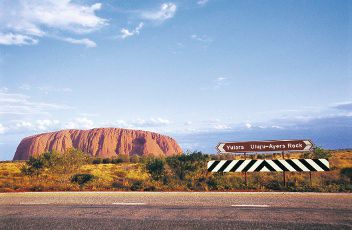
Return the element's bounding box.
[141,3,177,22]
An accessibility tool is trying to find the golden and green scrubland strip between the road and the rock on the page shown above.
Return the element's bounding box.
[0,149,352,192]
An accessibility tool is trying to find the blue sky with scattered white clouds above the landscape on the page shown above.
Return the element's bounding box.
[0,0,352,160]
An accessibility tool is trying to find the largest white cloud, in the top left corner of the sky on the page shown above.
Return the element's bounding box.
[0,0,107,45]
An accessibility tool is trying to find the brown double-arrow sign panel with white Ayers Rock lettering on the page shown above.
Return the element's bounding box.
[216,140,314,153]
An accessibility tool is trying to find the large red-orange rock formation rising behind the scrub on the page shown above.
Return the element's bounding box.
[13,128,182,160]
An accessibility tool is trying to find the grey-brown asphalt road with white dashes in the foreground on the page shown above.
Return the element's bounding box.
[0,192,352,229]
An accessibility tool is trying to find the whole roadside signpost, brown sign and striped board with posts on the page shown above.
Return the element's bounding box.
[212,140,322,186]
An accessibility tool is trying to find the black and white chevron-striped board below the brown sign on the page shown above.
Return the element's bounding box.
[207,159,330,172]
